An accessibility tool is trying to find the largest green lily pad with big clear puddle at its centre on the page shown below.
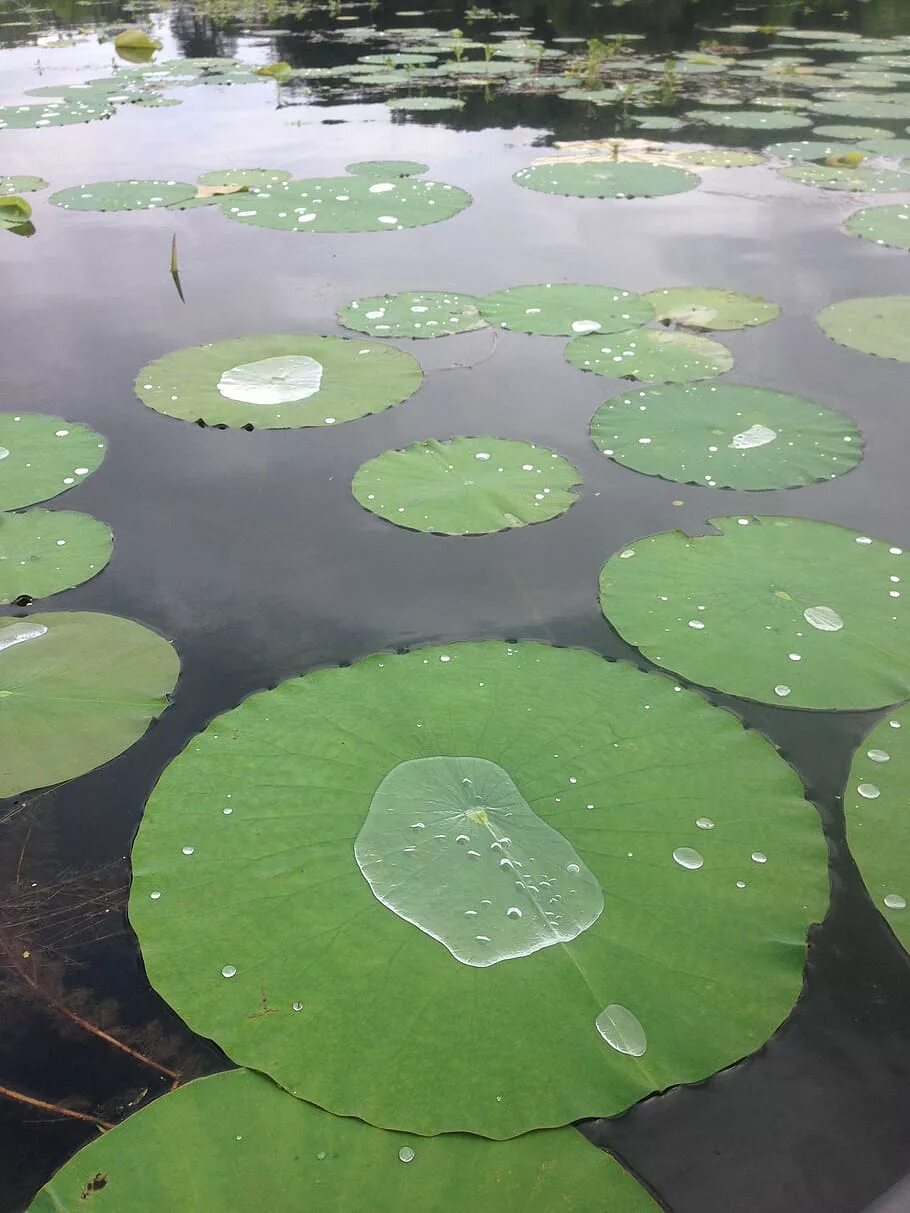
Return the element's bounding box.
[130,645,827,1135]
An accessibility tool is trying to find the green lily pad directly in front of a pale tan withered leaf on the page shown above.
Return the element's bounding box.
[512,160,699,198]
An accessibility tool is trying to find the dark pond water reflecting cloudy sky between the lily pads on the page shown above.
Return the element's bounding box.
[0,0,910,1213]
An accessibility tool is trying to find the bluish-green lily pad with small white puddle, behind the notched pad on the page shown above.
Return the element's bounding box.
[591,383,863,489]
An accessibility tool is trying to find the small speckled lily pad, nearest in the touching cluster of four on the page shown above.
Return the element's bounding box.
[565,329,733,383]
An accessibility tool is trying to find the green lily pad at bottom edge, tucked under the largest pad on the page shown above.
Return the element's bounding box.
[29,1070,658,1213]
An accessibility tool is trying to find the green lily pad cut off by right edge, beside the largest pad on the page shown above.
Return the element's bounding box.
[843,705,910,952]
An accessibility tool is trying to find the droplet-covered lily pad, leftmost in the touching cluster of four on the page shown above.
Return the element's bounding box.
[339,291,487,337]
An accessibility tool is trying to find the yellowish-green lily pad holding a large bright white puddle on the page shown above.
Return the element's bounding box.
[136,332,423,429]
